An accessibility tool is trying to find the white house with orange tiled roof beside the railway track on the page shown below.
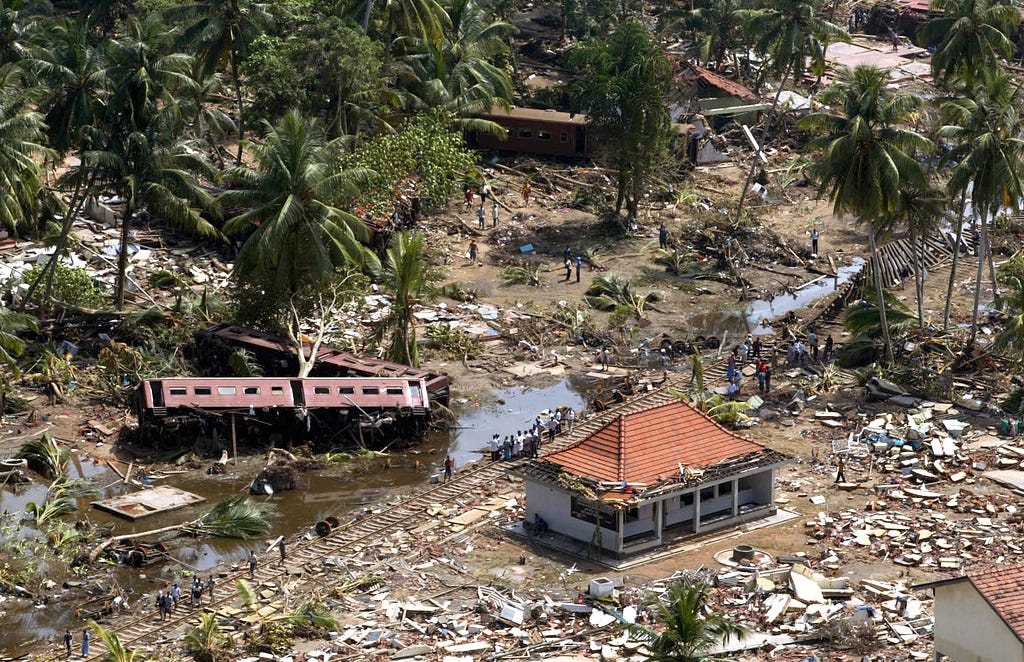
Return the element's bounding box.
[516,400,790,557]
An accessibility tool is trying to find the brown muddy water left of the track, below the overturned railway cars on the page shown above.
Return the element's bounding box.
[0,376,588,654]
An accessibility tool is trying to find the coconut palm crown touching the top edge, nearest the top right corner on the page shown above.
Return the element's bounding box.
[918,0,1021,85]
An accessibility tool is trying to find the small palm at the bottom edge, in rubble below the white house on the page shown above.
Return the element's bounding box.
[630,584,746,662]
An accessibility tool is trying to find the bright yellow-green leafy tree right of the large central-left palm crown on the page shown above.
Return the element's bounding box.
[342,110,477,218]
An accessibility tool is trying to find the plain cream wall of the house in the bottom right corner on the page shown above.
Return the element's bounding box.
[935,581,1024,662]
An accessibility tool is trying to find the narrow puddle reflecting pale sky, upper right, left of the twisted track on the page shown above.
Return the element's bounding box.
[686,257,864,344]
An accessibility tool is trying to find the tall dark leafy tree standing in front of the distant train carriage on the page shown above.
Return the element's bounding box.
[568,18,672,223]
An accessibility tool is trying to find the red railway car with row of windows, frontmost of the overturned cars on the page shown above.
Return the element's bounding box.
[136,377,430,447]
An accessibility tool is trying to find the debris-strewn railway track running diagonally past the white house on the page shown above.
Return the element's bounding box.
[46,376,682,661]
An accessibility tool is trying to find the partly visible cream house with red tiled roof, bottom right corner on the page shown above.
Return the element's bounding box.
[915,565,1024,662]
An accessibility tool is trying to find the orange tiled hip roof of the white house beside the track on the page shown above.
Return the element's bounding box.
[544,400,765,485]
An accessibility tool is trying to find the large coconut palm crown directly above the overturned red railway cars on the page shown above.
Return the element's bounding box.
[220,111,374,300]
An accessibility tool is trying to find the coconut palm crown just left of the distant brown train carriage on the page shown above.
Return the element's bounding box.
[403,0,516,133]
